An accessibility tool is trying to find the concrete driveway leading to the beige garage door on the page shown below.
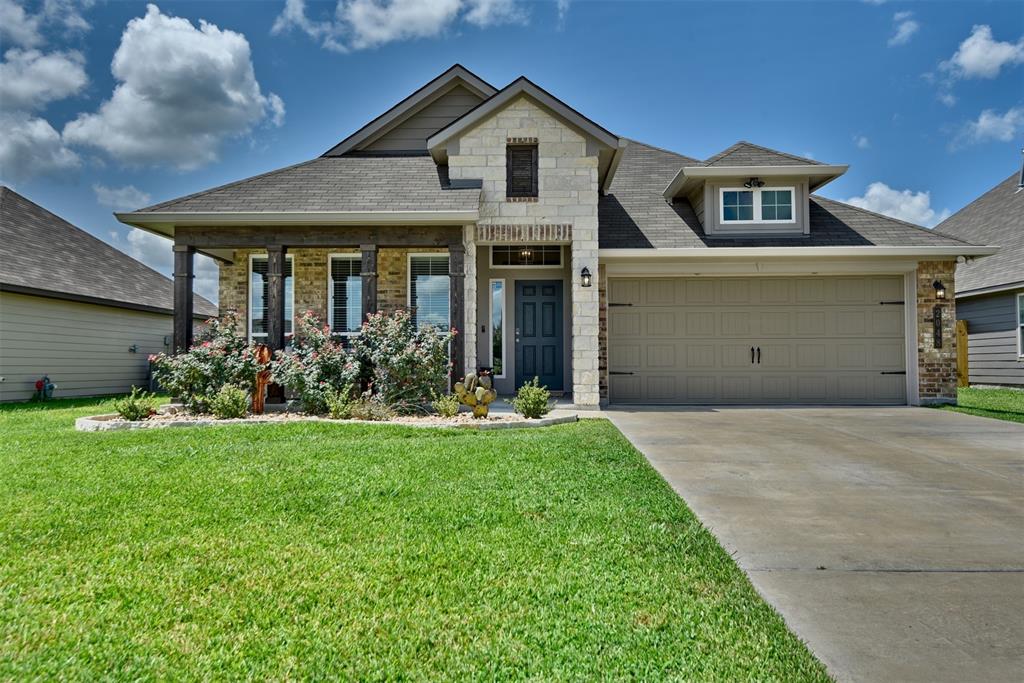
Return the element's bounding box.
[606,408,1024,681]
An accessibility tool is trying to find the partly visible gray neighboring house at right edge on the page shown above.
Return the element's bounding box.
[935,170,1024,386]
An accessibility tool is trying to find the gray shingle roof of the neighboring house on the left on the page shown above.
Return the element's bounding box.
[0,186,217,315]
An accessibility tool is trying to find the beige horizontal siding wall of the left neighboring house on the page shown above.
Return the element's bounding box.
[0,292,171,400]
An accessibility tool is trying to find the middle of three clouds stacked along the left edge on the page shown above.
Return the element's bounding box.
[0,47,89,112]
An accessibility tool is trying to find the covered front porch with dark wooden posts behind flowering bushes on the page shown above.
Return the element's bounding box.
[173,225,476,385]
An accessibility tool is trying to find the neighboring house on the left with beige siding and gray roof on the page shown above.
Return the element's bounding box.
[0,187,217,400]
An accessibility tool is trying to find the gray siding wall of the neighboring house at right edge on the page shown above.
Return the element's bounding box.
[956,290,1024,386]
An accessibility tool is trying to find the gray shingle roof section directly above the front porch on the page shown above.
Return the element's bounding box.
[140,155,480,212]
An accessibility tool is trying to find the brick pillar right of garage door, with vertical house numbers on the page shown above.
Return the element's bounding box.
[918,261,956,403]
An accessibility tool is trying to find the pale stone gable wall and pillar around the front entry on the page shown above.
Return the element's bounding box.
[449,97,600,407]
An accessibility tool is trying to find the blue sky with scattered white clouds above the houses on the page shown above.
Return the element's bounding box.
[0,0,1024,296]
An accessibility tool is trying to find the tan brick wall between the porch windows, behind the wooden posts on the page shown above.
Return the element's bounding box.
[219,247,446,331]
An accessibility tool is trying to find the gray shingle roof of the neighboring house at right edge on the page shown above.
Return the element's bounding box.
[935,171,1024,293]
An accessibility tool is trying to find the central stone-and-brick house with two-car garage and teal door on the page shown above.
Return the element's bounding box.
[118,66,994,407]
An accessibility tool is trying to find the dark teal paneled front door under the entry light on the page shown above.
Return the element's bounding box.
[515,280,563,391]
